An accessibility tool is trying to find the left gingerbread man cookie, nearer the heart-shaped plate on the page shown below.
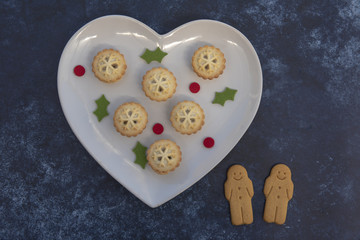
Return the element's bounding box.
[224,165,254,225]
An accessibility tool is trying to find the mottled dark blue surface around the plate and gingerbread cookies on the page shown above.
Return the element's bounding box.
[0,0,360,240]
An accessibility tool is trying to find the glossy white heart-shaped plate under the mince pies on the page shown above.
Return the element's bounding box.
[58,16,262,207]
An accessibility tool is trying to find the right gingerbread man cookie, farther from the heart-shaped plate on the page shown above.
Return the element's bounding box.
[264,164,294,224]
